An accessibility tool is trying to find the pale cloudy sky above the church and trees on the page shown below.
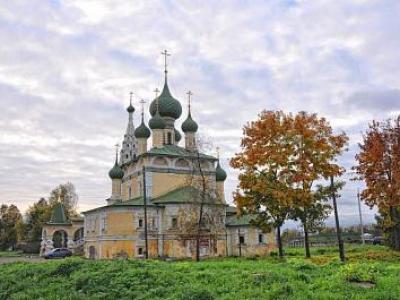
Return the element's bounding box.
[0,0,400,224]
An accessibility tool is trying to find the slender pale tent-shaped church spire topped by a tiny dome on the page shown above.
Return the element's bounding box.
[120,92,138,164]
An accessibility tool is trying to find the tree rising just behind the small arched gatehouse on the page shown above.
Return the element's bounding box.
[49,182,78,218]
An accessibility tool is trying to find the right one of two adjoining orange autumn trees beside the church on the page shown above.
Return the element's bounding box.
[289,112,348,257]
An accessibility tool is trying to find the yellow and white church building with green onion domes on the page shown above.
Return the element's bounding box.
[42,53,276,259]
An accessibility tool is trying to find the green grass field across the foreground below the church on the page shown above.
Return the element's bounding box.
[0,246,400,300]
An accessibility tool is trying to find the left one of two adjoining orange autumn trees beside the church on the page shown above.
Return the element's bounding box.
[230,111,294,257]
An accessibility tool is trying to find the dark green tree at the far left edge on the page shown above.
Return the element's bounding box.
[0,204,22,250]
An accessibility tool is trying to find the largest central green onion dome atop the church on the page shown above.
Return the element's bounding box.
[150,81,182,119]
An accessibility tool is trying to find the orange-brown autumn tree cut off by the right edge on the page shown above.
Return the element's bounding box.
[354,116,400,251]
